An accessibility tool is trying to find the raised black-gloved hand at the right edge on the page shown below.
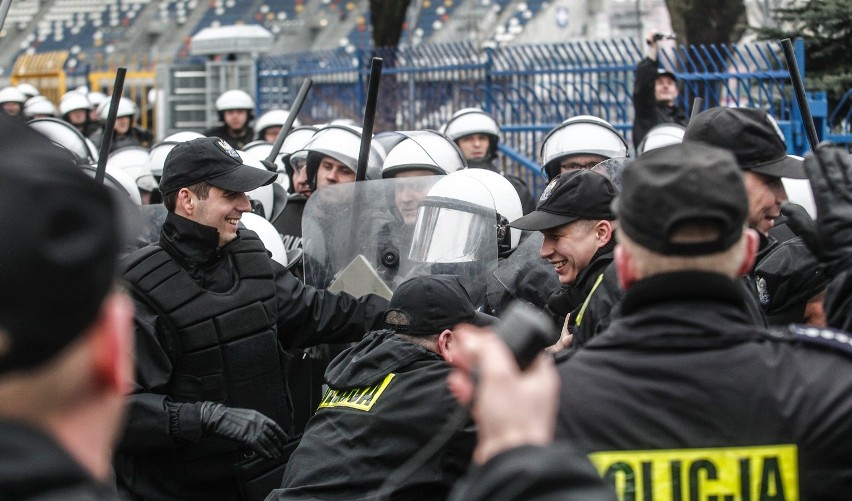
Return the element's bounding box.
[782,143,852,276]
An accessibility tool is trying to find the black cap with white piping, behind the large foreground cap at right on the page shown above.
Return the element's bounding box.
[683,107,808,179]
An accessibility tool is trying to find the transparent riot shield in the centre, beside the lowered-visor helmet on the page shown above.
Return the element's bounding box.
[302,176,442,297]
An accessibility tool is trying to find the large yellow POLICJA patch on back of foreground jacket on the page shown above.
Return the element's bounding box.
[589,445,799,501]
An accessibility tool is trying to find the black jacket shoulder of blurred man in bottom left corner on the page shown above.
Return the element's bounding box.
[0,420,118,501]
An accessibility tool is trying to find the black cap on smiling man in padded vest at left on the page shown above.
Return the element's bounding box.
[160,137,277,195]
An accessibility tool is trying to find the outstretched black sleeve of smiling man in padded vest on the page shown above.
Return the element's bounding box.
[274,263,388,349]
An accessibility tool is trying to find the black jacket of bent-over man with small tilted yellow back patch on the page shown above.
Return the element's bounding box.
[274,331,475,500]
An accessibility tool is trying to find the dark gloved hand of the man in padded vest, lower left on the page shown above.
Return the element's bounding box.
[201,402,287,459]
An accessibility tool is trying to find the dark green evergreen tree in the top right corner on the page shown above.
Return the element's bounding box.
[758,0,852,125]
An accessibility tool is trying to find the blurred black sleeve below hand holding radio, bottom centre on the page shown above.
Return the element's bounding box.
[449,442,616,501]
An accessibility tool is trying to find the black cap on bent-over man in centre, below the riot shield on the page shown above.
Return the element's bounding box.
[384,275,497,336]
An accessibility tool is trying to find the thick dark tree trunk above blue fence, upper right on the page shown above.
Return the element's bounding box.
[666,0,746,44]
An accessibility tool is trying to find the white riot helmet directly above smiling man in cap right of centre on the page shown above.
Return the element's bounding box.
[541,115,630,179]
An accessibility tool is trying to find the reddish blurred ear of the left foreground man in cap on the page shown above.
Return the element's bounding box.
[86,293,133,395]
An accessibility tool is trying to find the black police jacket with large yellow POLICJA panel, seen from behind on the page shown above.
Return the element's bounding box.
[557,272,852,500]
